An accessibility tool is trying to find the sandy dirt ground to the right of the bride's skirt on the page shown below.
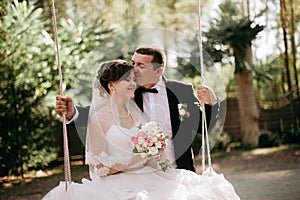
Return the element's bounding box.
[198,146,300,200]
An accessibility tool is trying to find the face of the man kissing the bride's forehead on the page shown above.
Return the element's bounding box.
[131,53,162,88]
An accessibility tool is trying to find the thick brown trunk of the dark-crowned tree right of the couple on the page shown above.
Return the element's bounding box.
[234,45,260,147]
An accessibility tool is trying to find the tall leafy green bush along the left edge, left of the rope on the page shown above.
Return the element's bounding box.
[0,1,56,175]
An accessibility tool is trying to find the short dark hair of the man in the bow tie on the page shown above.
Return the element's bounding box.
[135,47,166,68]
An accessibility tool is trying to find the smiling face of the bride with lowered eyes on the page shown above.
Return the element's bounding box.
[115,70,136,99]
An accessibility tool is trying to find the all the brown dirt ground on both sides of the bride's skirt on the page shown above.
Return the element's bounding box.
[0,145,300,200]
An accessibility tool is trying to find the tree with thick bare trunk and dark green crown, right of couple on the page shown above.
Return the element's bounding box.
[208,0,263,147]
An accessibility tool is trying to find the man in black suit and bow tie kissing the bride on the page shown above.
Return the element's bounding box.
[56,47,219,171]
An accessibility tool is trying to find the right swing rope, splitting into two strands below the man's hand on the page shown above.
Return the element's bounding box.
[198,0,211,174]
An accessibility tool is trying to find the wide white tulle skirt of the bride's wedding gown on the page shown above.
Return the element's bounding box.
[43,167,240,200]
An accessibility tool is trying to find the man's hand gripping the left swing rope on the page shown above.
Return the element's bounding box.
[55,96,75,120]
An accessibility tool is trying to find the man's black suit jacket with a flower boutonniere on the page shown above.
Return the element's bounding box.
[75,78,219,171]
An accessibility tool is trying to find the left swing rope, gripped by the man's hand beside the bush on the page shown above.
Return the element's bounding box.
[51,0,71,190]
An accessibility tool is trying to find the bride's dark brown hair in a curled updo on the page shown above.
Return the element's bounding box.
[96,60,133,94]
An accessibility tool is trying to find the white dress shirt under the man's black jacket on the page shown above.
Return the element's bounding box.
[143,78,176,168]
